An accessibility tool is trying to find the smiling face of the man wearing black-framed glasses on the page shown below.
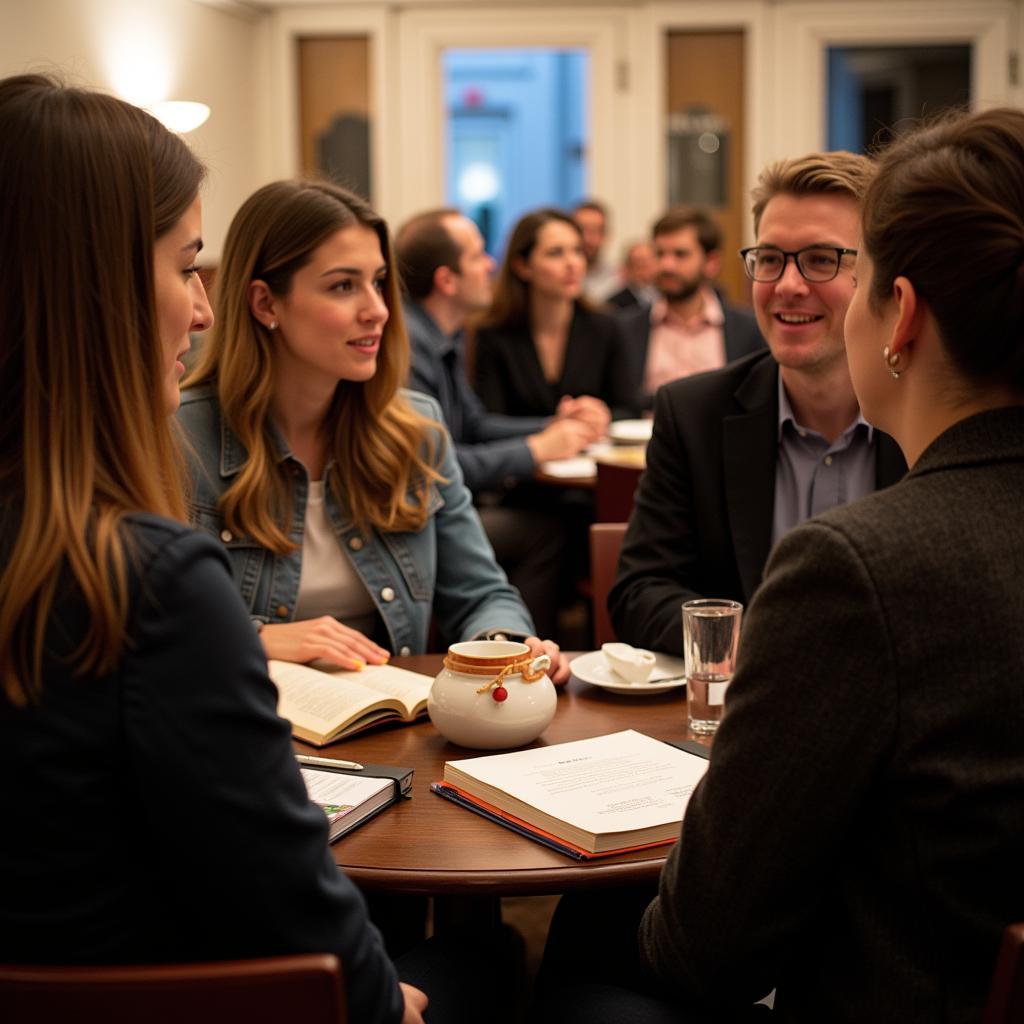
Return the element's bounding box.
[753,194,860,373]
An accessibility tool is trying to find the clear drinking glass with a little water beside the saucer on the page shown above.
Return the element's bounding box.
[683,598,743,735]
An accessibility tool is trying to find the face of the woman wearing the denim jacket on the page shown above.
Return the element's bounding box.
[266,224,388,387]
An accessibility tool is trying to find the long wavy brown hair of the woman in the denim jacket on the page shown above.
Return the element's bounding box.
[185,181,440,554]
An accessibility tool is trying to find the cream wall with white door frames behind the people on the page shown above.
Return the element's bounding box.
[6,0,1024,262]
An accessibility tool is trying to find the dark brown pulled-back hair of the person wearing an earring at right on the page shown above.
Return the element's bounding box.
[863,108,1024,389]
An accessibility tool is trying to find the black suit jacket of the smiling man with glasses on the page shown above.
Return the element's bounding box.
[608,352,906,654]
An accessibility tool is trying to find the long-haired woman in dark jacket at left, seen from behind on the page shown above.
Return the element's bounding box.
[0,75,430,1024]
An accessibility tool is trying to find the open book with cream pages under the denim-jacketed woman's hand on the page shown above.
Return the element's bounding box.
[269,662,434,746]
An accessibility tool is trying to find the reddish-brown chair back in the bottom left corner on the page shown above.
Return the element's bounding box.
[0,950,348,1024]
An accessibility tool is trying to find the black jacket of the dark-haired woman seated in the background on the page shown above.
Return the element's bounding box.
[475,306,632,416]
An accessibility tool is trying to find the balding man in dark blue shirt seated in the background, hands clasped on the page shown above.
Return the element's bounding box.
[395,209,608,636]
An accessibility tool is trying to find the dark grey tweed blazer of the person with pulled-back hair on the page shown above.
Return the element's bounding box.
[641,408,1024,1024]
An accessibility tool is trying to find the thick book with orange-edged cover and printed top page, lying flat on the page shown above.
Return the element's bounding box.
[431,729,708,859]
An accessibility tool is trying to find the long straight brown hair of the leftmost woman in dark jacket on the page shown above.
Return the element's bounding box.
[0,75,204,703]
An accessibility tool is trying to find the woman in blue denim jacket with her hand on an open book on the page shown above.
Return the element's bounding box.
[179,181,568,682]
